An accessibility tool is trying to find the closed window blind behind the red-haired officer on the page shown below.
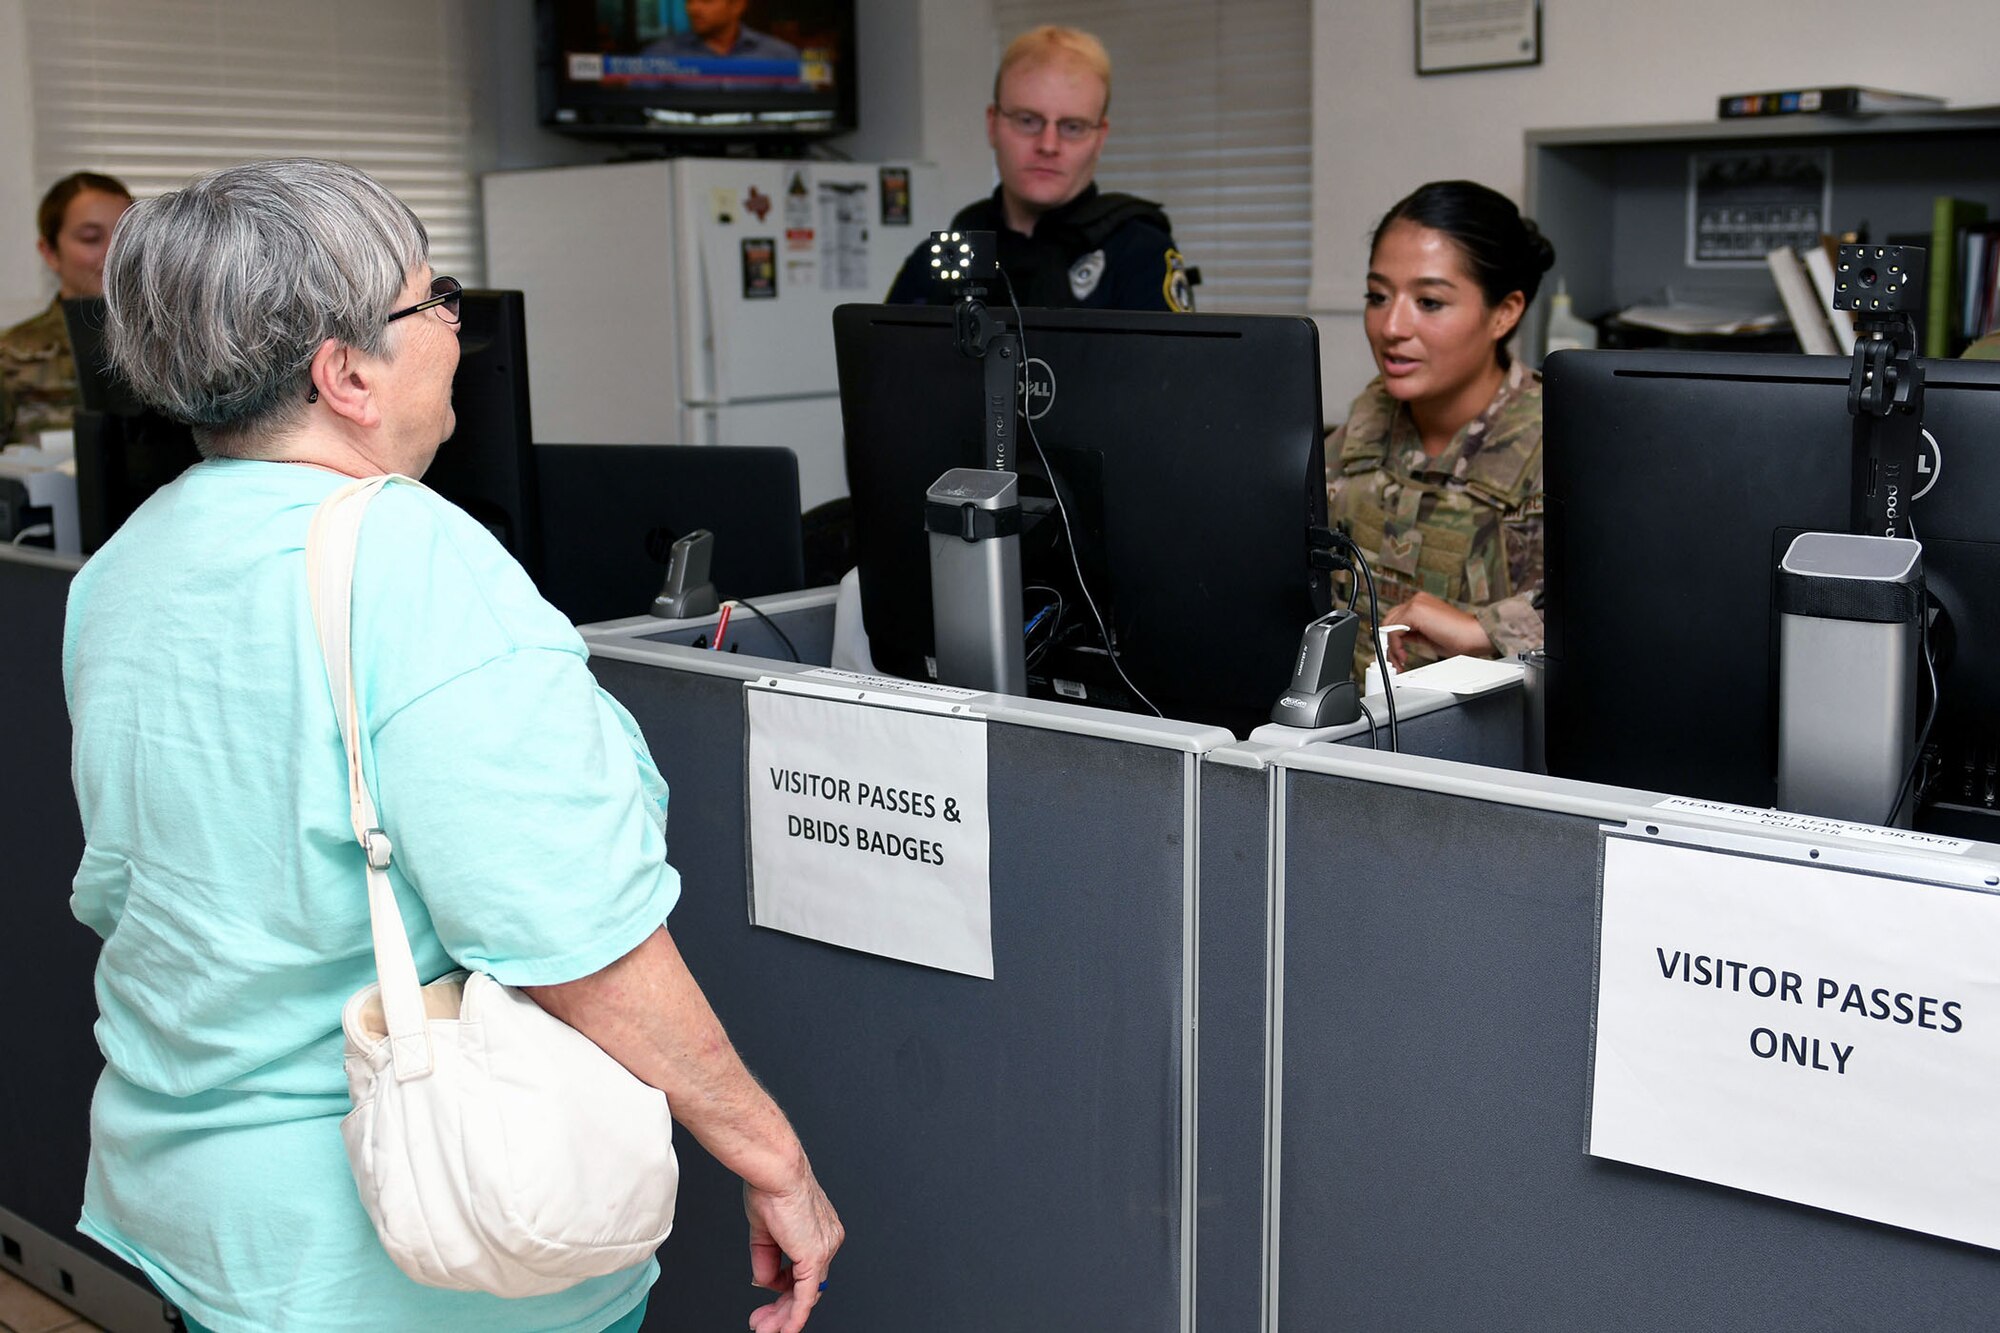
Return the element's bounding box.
[994,0,1312,312]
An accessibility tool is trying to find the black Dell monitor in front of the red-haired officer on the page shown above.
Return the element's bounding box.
[834,306,1328,731]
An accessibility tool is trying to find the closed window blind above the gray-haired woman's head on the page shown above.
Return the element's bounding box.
[26,0,484,286]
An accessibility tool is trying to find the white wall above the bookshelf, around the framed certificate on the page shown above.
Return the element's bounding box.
[1310,0,2000,418]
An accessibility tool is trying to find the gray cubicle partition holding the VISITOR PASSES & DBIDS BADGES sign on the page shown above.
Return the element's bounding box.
[592,636,1268,1333]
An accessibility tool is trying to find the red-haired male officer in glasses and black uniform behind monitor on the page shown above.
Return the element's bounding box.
[888,26,1194,310]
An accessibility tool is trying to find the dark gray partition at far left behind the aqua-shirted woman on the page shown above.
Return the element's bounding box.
[0,546,168,1333]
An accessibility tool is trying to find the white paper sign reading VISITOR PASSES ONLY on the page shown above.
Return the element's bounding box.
[1590,837,2000,1249]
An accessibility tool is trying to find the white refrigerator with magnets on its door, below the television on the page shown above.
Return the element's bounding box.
[484,158,944,508]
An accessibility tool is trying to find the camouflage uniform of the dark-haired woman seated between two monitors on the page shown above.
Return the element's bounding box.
[1326,360,1542,677]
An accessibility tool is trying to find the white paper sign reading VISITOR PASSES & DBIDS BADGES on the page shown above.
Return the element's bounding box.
[744,687,994,979]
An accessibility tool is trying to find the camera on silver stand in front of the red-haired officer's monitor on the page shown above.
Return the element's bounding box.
[924,230,1028,695]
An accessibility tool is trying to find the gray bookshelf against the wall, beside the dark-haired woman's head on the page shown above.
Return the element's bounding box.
[1520,106,2000,360]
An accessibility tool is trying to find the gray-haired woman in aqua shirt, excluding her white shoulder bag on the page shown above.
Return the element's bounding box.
[64,160,842,1333]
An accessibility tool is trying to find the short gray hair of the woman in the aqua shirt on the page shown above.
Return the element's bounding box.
[104,158,430,456]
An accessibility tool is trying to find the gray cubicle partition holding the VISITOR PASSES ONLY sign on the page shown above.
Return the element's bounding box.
[1266,747,2000,1331]
